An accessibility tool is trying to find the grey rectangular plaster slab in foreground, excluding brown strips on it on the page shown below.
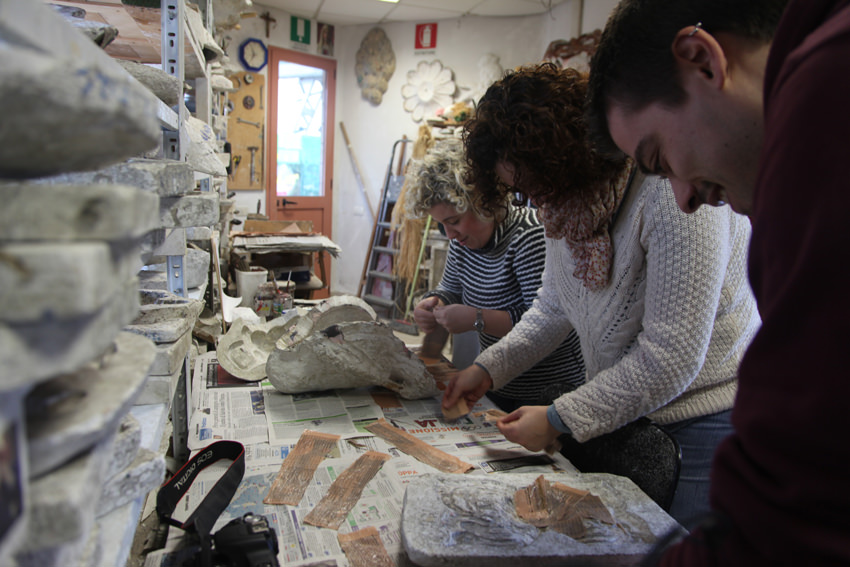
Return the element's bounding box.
[401,472,684,567]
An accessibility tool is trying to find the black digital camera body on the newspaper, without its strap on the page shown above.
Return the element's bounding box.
[213,512,280,567]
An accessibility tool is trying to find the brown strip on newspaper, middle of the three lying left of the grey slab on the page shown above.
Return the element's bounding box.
[304,451,392,530]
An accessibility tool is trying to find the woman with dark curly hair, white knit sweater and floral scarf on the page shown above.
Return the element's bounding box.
[443,64,759,523]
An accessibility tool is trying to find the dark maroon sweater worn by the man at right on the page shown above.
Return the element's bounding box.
[662,0,850,567]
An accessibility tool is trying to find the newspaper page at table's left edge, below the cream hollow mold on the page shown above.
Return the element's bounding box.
[187,351,269,450]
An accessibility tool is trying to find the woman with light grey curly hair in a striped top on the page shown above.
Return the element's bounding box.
[403,139,584,411]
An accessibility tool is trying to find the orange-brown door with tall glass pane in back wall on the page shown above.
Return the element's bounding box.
[266,47,336,298]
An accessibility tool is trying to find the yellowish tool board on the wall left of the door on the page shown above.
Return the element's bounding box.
[227,71,266,190]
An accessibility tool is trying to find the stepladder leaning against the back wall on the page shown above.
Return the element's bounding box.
[357,136,412,321]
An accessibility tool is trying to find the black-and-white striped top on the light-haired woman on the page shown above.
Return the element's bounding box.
[426,206,585,405]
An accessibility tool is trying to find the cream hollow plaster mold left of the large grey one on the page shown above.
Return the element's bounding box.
[216,309,299,382]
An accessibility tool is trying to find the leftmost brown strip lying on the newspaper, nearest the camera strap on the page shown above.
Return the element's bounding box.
[263,429,340,506]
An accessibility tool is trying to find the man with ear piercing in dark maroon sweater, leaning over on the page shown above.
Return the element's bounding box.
[588,0,850,567]
